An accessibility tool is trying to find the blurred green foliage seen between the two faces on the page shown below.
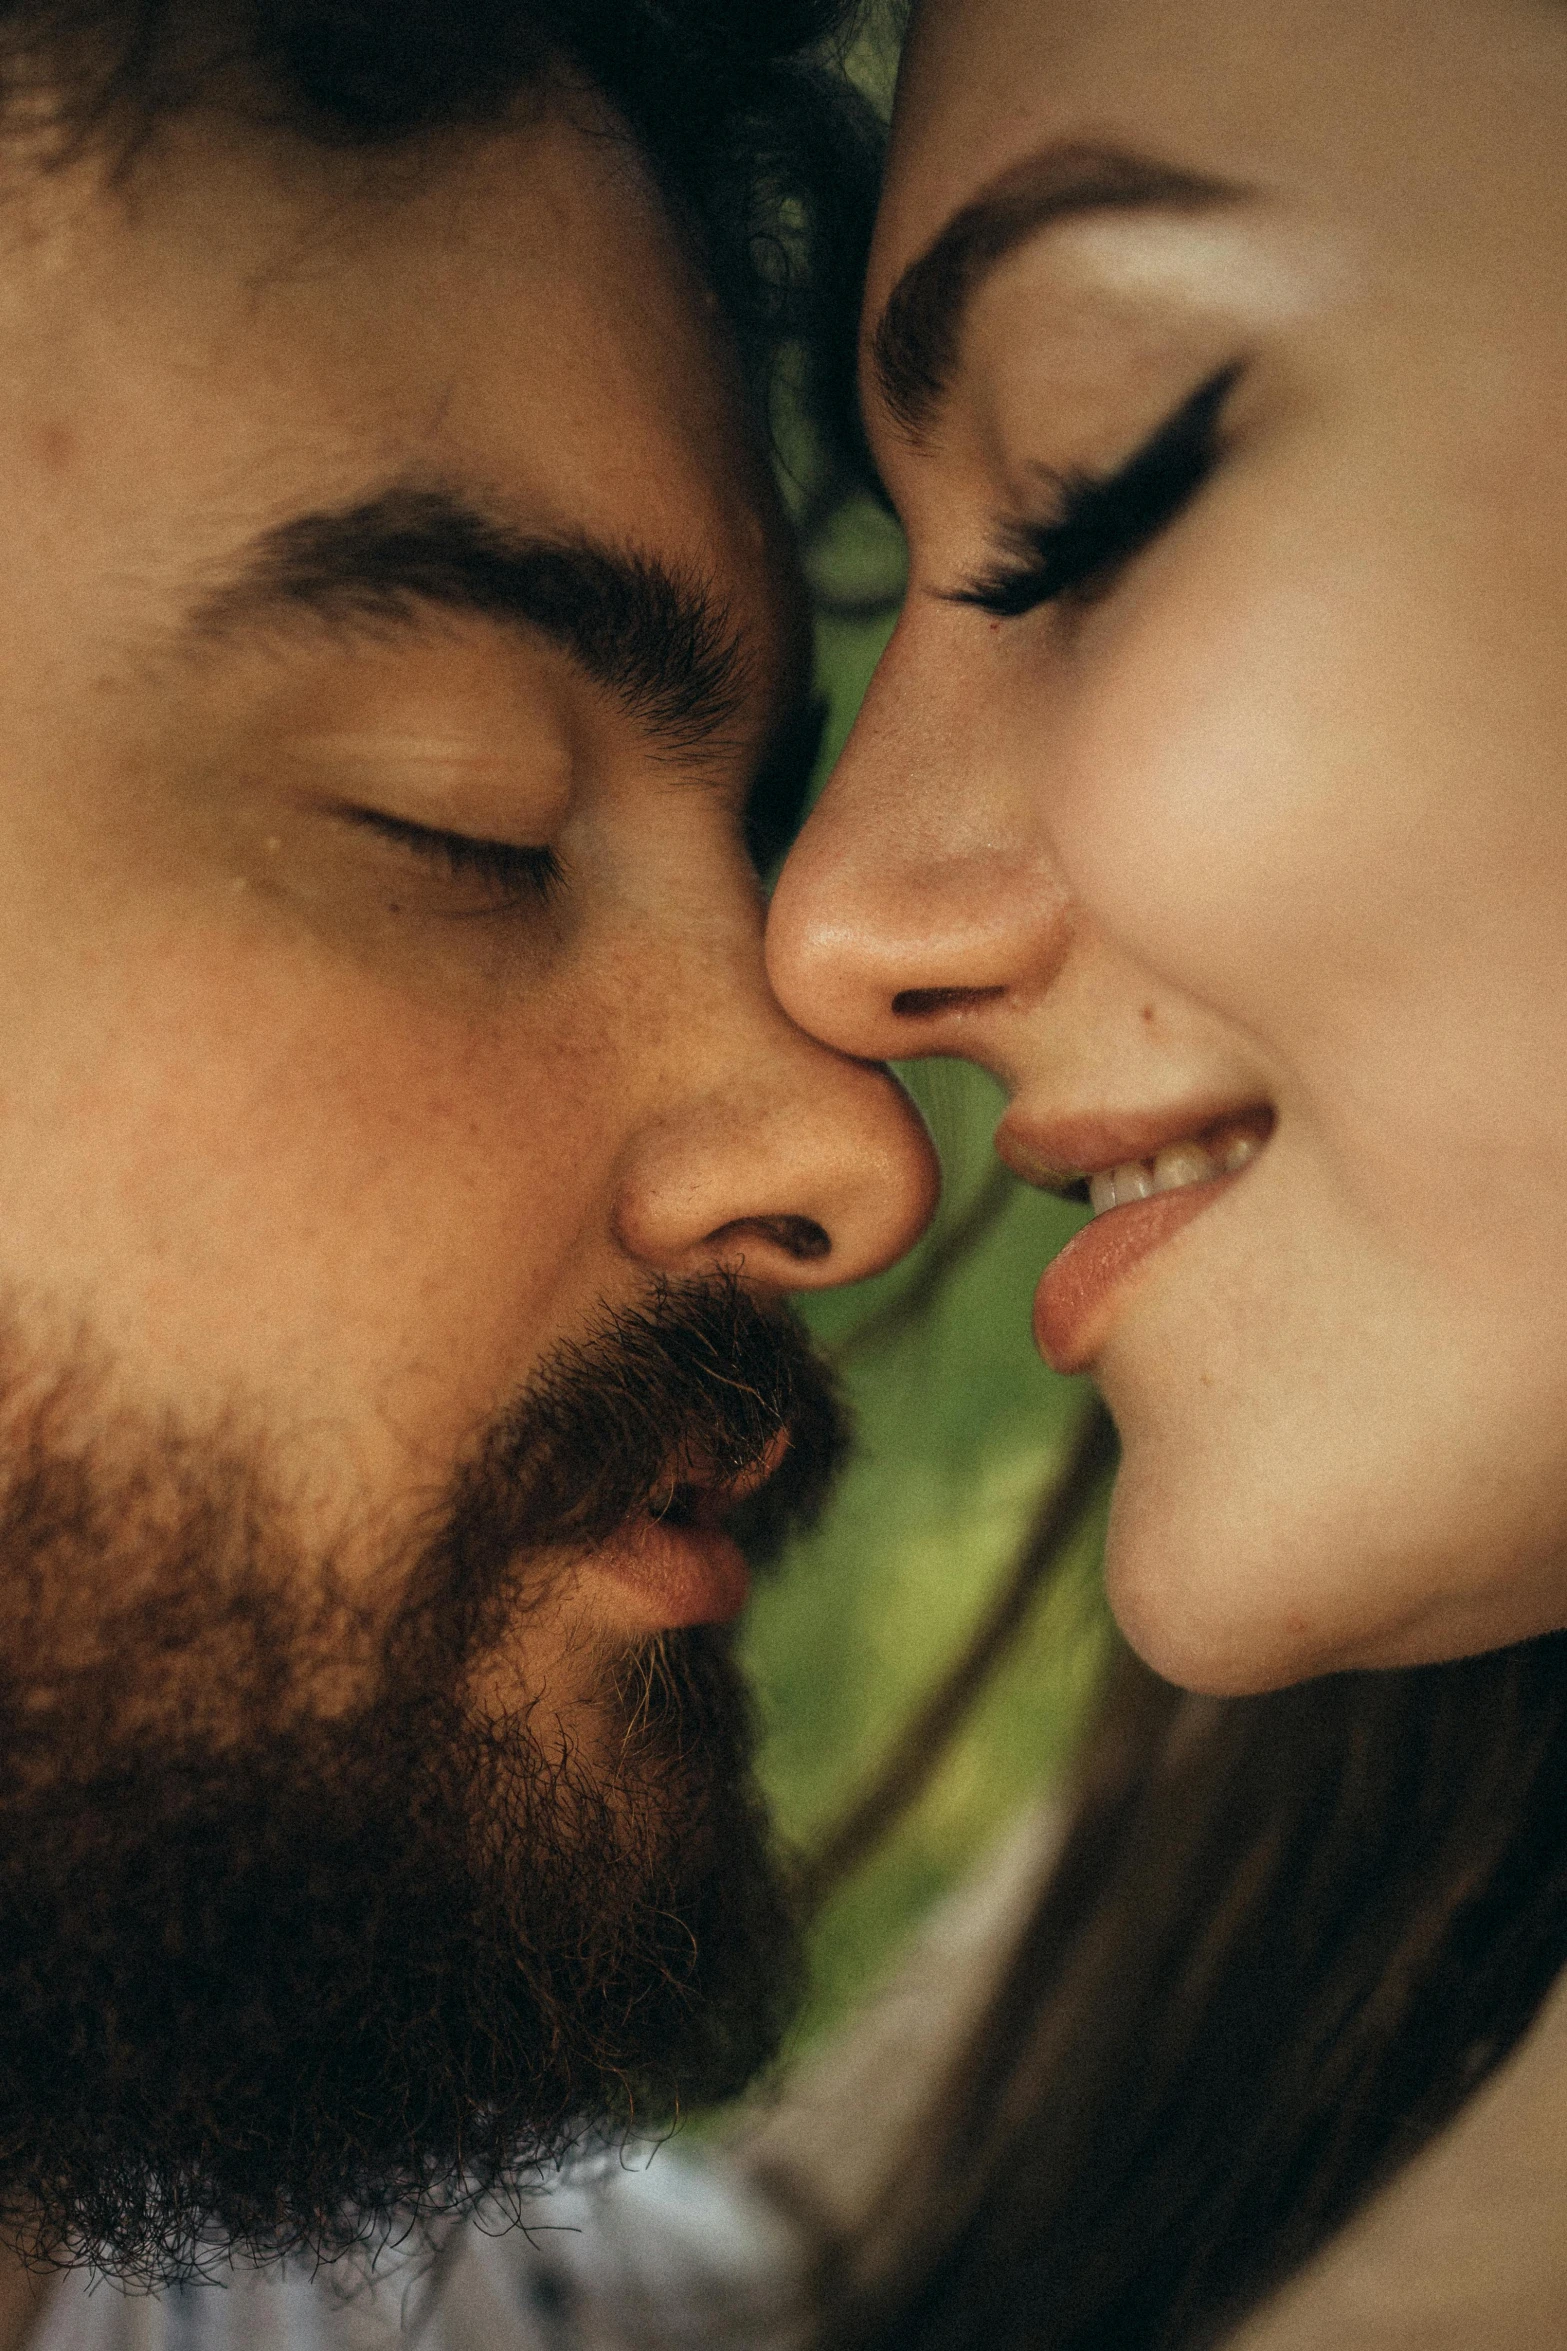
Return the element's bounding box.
[747,611,1107,2038]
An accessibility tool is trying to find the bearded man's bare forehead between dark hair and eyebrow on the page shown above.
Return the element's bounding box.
[0,80,799,698]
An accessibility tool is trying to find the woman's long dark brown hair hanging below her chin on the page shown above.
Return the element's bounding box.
[829,1589,1567,2351]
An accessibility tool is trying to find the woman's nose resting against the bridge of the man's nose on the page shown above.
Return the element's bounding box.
[766,637,1071,1081]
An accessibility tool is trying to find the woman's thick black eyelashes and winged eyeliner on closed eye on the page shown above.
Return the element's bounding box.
[951,364,1240,621]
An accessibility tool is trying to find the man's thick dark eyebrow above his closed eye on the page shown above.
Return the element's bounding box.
[188,487,752,755]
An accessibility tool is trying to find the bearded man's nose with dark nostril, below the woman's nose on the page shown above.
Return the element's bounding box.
[613,916,940,1291]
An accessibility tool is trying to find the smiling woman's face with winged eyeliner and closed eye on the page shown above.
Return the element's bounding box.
[771,0,1567,1690]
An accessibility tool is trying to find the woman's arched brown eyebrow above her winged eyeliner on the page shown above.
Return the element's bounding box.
[872,141,1247,440]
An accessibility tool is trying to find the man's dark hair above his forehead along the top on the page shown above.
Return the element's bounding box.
[0,0,881,477]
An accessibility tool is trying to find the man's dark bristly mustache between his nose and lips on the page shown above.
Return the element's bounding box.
[434,1277,848,1589]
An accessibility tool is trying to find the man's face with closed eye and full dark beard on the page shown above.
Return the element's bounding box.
[0,86,930,2266]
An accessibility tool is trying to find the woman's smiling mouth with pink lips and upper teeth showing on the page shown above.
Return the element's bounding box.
[996,1107,1273,1373]
